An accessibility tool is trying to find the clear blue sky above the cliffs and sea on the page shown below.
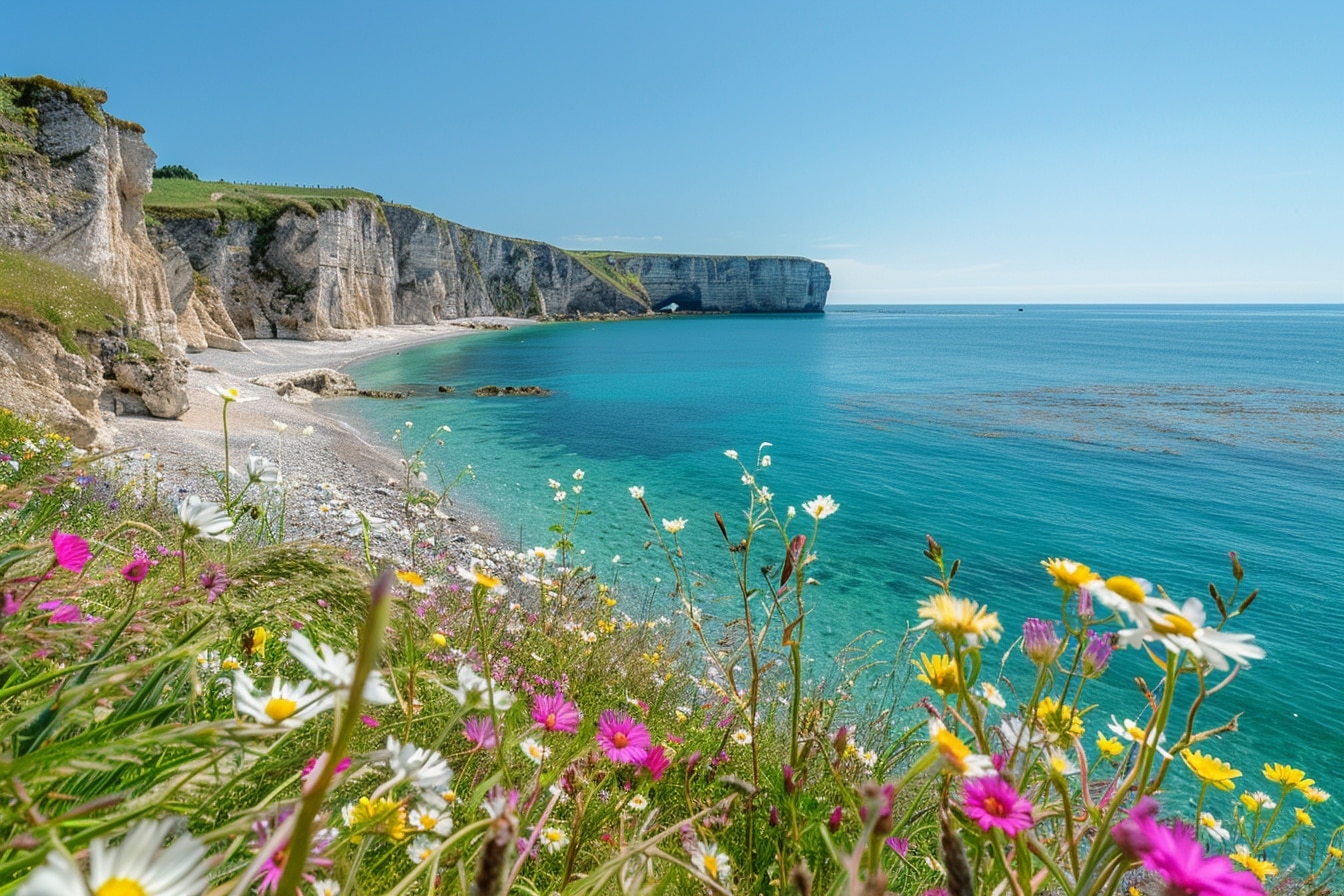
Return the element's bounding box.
[0,0,1344,304]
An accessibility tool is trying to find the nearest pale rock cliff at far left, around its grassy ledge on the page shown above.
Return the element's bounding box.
[0,77,188,446]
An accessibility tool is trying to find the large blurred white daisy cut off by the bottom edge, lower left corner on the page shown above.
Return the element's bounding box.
[17,818,208,896]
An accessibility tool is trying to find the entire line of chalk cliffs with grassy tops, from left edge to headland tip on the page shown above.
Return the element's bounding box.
[0,75,831,445]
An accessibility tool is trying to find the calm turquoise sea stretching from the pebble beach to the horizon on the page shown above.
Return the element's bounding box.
[341,305,1344,809]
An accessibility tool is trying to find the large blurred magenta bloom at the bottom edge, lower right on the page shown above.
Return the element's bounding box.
[1111,797,1265,896]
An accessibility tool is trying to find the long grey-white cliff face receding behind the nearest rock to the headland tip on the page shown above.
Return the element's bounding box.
[160,199,831,343]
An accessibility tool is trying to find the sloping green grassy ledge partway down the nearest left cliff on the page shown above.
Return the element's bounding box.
[0,249,124,352]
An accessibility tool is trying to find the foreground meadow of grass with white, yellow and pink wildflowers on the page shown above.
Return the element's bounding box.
[0,405,1344,896]
